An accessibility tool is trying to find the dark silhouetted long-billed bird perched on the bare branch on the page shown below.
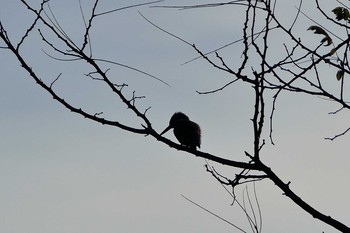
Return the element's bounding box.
[160,112,201,150]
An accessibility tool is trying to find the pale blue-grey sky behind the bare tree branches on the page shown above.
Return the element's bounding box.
[0,0,350,233]
